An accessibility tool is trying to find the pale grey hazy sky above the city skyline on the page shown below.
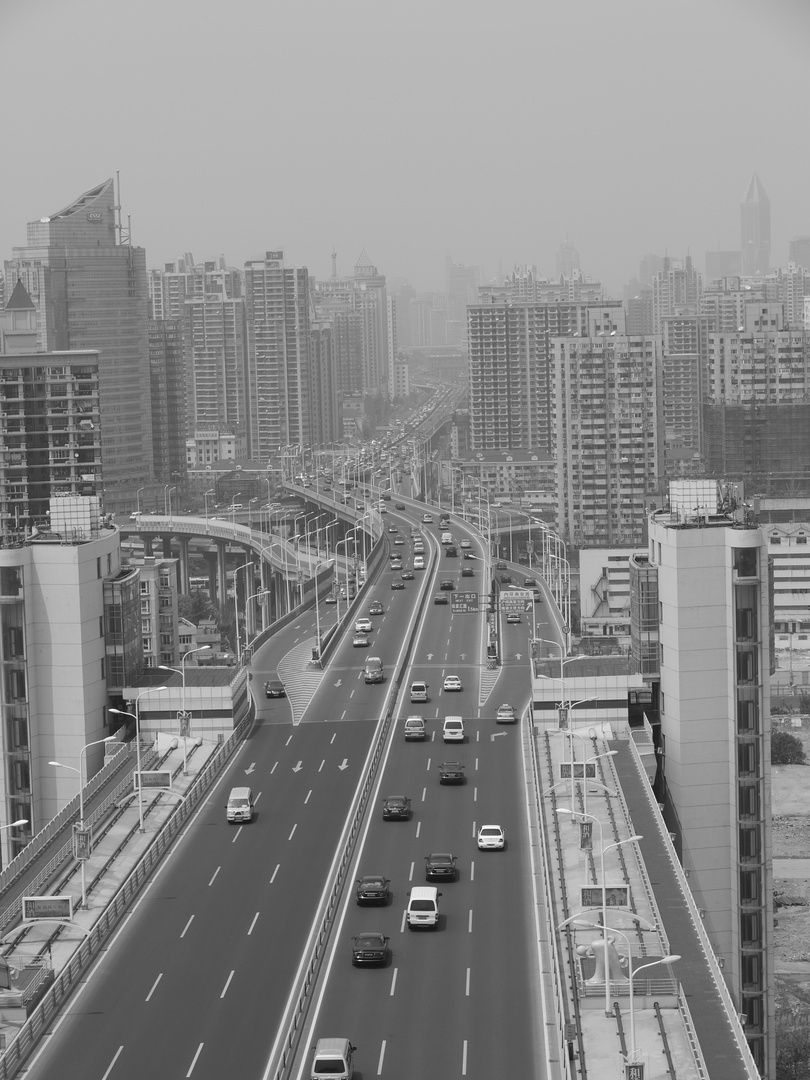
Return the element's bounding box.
[0,0,810,292]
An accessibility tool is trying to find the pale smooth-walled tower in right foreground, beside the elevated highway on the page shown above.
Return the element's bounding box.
[648,490,774,1075]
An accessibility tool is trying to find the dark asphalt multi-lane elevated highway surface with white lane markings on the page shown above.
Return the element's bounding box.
[23,501,544,1080]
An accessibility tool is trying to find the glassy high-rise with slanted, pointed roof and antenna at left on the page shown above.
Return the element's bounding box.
[5,179,154,509]
